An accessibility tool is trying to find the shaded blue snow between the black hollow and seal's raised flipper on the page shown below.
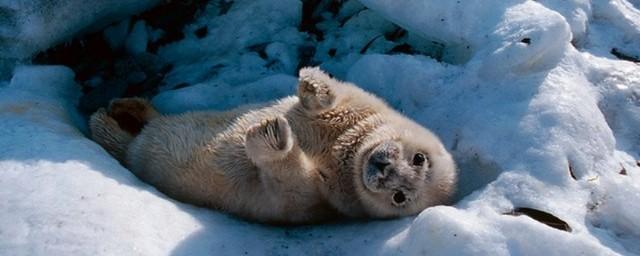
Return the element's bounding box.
[159,0,304,88]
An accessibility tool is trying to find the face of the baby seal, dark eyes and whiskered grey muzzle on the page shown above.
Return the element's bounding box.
[358,126,455,218]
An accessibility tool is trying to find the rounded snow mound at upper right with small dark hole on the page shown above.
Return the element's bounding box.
[361,0,571,78]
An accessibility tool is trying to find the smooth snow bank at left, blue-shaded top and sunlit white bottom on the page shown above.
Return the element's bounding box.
[0,66,205,255]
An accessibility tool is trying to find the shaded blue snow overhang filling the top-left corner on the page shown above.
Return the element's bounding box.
[0,0,160,78]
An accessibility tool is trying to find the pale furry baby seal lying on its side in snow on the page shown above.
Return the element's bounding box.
[90,68,457,224]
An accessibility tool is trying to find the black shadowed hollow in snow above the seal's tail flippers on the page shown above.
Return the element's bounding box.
[33,0,208,114]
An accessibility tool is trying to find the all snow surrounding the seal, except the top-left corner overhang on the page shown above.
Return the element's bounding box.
[0,0,640,255]
